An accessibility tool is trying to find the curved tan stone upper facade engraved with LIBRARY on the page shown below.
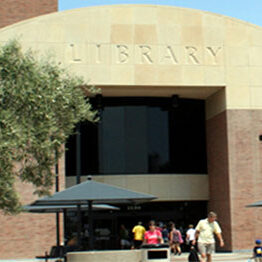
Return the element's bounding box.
[0,5,262,116]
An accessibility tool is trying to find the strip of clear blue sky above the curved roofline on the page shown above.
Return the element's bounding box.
[58,0,262,26]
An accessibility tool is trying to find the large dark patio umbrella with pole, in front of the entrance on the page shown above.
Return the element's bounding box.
[32,176,156,250]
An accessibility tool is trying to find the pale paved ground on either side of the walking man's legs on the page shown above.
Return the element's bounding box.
[171,252,253,262]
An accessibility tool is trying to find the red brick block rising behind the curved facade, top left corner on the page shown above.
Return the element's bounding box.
[0,0,58,28]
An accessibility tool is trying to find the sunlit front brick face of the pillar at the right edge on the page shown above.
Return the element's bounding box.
[227,110,262,250]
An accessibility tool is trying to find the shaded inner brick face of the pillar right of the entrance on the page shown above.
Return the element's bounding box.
[206,112,232,250]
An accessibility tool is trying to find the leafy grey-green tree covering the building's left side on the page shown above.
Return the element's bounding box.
[0,40,97,214]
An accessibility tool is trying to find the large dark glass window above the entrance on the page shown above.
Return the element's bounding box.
[66,97,207,176]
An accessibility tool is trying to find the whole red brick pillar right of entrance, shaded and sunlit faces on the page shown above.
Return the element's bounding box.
[207,110,262,250]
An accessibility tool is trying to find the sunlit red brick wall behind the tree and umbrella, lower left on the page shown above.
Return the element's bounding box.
[0,154,65,260]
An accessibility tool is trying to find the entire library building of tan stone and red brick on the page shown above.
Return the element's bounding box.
[0,0,262,259]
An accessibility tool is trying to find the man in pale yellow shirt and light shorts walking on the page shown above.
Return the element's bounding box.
[192,212,224,262]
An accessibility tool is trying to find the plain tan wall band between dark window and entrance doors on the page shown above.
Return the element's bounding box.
[66,174,209,201]
